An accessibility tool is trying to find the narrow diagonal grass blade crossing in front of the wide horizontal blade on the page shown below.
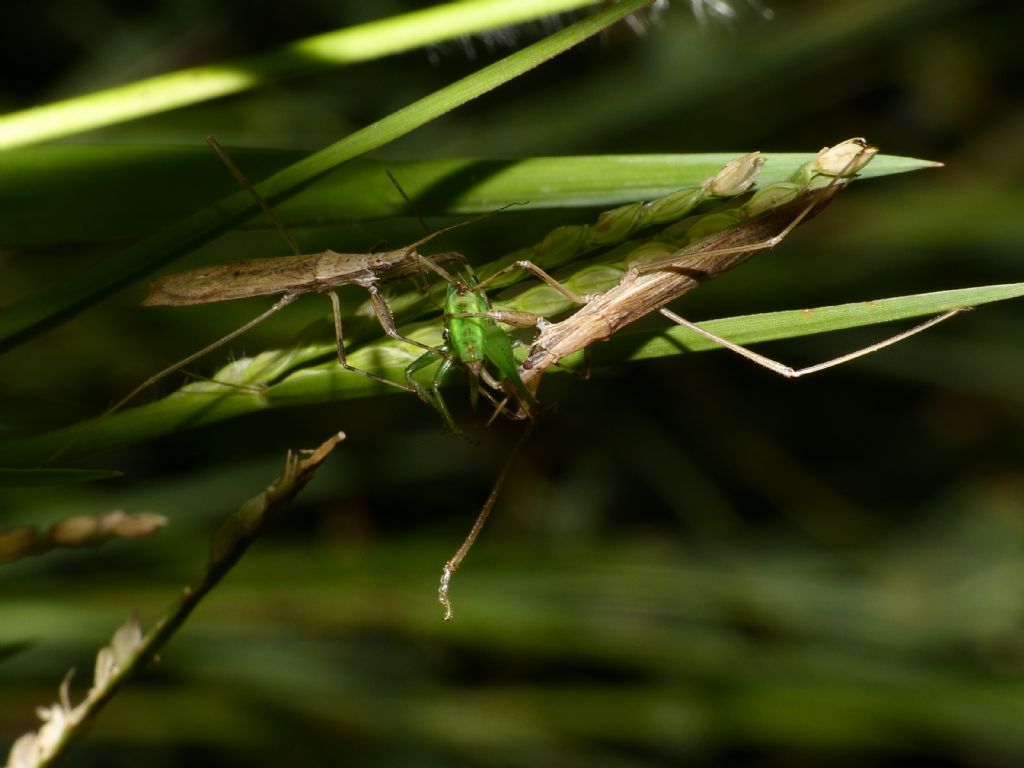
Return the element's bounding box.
[0,0,646,351]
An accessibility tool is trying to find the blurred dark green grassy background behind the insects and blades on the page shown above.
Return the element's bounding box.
[0,0,1024,766]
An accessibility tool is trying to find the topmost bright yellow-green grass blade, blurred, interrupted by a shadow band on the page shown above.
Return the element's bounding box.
[0,0,595,148]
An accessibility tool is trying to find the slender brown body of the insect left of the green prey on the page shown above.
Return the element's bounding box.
[142,248,461,306]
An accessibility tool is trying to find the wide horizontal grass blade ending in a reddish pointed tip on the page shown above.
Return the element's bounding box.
[0,145,937,251]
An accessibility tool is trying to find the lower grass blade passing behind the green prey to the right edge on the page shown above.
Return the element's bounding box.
[6,283,1024,466]
